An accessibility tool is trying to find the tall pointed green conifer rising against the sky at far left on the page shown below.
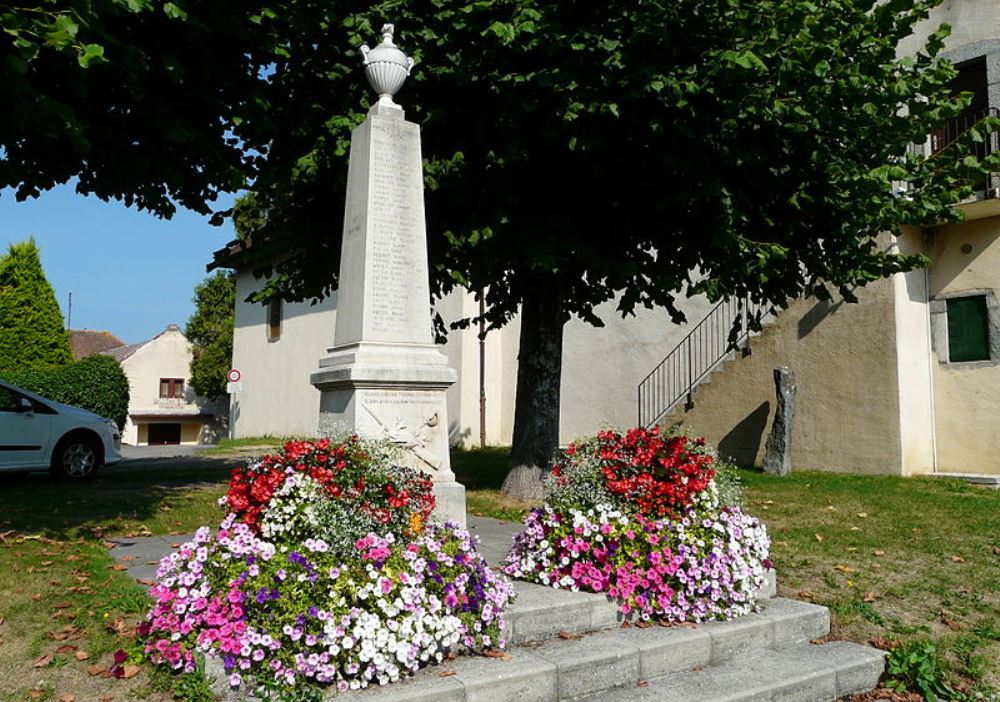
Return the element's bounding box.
[0,238,73,370]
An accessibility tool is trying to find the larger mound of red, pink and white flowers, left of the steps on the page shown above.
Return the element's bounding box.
[139,437,513,699]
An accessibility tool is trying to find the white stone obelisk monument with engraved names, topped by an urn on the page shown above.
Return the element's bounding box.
[311,24,465,524]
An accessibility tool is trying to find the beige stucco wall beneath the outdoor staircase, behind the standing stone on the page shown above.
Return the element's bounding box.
[665,280,904,474]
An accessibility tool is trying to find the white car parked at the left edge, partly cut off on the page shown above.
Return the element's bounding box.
[0,382,121,480]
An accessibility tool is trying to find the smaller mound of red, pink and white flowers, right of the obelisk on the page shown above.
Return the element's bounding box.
[504,428,770,622]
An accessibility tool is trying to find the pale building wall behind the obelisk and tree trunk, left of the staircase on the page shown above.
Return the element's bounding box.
[233,272,711,446]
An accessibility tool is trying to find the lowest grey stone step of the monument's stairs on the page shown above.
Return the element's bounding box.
[578,641,885,702]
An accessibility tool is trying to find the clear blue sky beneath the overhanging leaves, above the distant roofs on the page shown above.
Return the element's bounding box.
[0,185,234,343]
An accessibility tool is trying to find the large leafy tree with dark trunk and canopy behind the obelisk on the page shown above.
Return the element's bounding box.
[0,0,995,492]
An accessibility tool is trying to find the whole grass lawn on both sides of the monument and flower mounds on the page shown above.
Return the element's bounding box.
[0,448,1000,702]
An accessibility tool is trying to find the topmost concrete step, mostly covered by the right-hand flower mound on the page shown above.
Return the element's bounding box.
[507,570,775,644]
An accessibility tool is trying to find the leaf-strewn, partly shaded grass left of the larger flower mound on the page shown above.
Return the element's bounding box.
[0,459,231,702]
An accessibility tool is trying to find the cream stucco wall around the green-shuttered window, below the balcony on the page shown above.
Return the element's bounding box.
[929,217,1000,473]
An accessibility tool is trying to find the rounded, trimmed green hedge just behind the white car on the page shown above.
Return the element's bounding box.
[0,356,128,429]
